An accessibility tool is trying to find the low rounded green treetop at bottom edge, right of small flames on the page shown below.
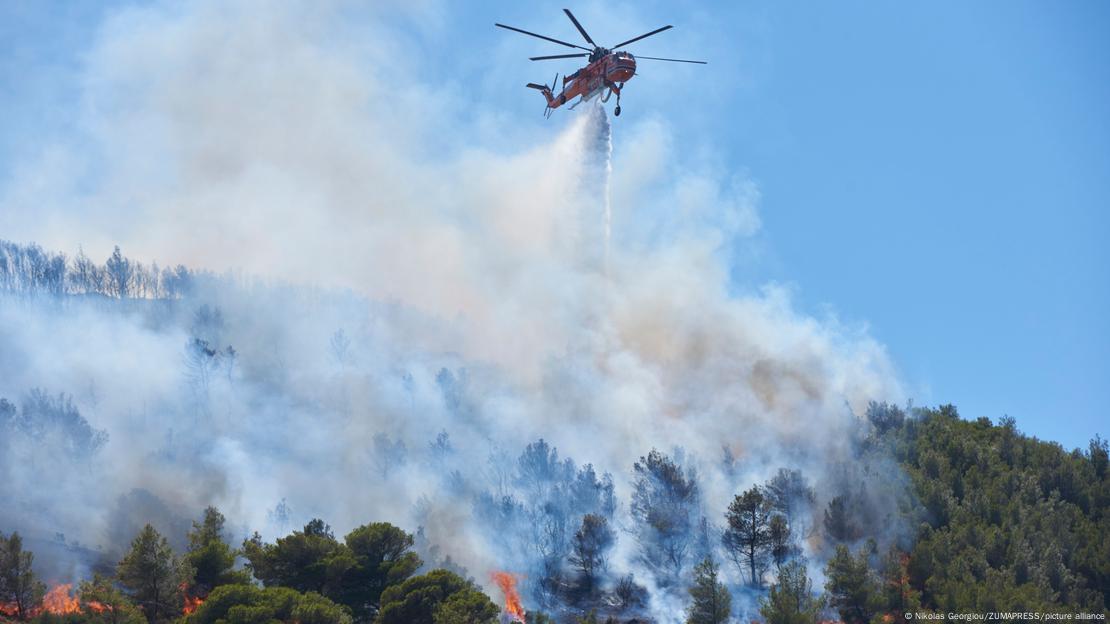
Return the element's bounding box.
[184,584,352,624]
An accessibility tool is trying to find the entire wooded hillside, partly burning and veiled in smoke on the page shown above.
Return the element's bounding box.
[0,238,1110,624]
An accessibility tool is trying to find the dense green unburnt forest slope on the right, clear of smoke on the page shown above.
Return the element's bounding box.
[826,405,1110,622]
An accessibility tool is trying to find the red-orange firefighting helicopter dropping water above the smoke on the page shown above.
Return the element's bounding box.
[494,9,706,117]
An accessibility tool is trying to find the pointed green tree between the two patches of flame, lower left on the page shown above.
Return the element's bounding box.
[115,524,192,622]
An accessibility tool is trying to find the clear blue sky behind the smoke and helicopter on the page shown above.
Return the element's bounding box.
[0,1,1110,446]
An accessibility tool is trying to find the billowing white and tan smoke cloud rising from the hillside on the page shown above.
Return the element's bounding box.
[0,2,901,612]
